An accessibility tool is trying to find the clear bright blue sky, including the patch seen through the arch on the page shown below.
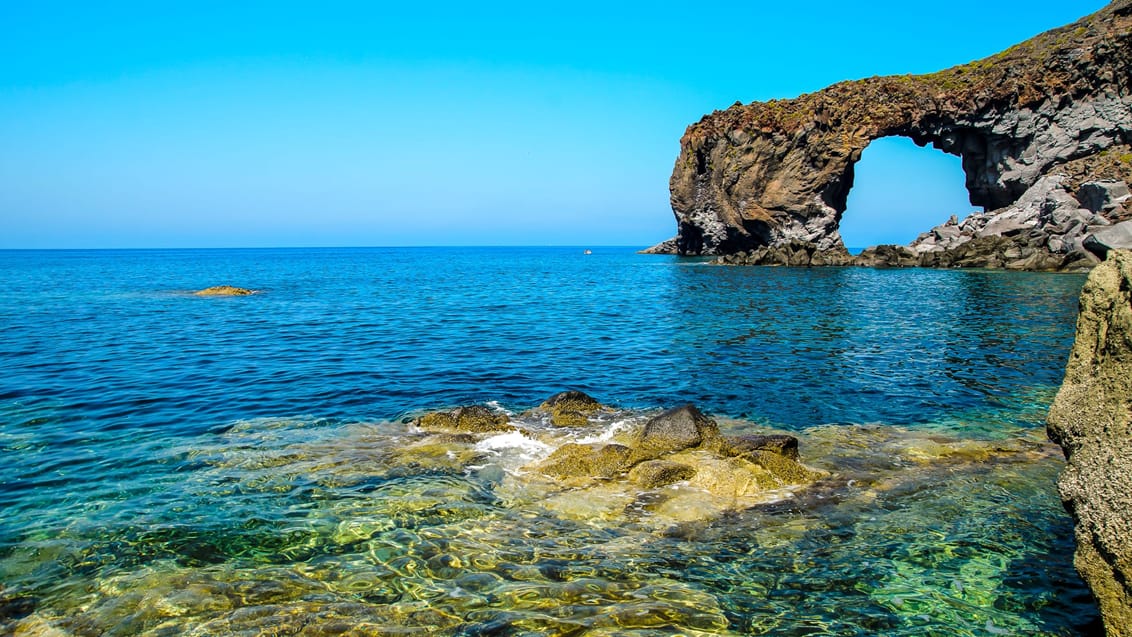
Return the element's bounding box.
[0,0,1105,248]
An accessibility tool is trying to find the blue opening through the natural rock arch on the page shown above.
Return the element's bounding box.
[838,137,981,253]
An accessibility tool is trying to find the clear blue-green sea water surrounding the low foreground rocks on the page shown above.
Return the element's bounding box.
[0,247,1097,636]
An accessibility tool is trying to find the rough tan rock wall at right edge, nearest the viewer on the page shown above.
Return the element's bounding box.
[1048,251,1132,637]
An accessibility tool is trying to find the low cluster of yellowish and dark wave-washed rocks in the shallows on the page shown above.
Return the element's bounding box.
[406,391,827,528]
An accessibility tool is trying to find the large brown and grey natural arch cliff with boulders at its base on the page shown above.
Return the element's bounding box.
[650,0,1132,269]
